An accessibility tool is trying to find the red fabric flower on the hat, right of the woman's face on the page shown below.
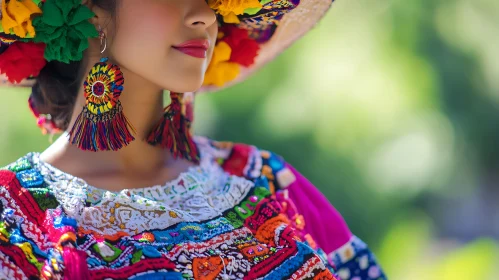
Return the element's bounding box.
[221,25,260,67]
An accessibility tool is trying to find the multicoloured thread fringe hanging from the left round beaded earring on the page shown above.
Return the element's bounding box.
[69,101,135,152]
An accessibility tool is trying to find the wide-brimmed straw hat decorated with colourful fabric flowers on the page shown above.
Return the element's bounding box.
[0,0,332,92]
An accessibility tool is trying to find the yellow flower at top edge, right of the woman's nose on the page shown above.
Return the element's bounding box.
[208,0,263,23]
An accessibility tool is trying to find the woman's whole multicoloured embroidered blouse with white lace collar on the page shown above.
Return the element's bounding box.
[0,137,386,280]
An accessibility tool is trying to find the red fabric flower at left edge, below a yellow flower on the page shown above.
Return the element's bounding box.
[0,41,47,83]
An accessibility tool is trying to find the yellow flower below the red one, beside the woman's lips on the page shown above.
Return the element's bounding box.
[203,42,241,87]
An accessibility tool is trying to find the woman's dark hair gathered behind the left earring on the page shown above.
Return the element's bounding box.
[31,0,117,130]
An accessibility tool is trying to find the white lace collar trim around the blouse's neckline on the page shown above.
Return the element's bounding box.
[24,137,254,236]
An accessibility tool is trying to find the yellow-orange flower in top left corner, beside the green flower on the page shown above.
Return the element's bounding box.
[2,0,42,38]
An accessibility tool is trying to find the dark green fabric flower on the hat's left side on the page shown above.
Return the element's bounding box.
[33,0,99,63]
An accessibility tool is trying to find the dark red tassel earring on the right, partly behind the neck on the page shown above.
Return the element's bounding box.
[147,92,199,163]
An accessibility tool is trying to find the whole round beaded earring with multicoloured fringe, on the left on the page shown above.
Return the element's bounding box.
[69,28,135,151]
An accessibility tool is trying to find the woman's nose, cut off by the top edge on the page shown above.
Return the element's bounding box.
[183,0,217,28]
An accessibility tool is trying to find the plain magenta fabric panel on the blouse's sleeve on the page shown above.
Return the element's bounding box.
[286,163,352,254]
